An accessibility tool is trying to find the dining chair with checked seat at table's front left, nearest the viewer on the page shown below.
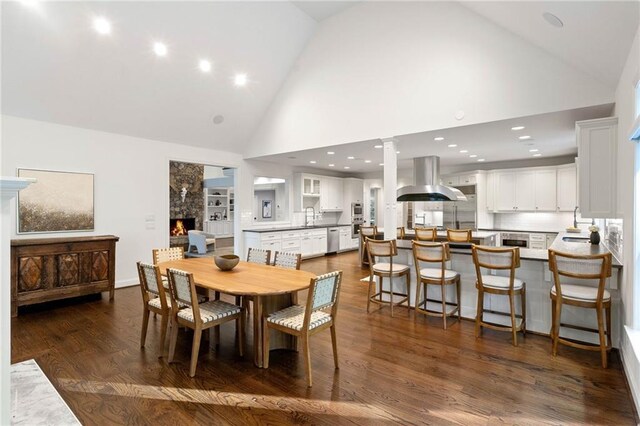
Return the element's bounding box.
[167,268,245,377]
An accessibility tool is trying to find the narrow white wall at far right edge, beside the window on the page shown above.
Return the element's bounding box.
[615,25,640,410]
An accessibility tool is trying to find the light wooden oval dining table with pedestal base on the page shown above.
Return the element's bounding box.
[158,257,316,368]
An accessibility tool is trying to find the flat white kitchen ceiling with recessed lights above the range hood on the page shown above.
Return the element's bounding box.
[256,104,613,173]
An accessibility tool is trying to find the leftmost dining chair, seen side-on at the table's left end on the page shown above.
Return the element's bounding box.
[137,262,171,357]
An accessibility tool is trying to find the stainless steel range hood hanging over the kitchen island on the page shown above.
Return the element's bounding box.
[397,155,467,201]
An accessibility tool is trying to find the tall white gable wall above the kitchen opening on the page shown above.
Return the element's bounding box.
[245,2,613,157]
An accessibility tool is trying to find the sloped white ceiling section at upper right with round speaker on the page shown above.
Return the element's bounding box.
[460,0,640,89]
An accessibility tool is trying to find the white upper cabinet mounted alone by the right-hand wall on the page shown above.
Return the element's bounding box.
[576,117,619,218]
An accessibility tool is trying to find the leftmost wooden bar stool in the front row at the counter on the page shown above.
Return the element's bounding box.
[366,238,411,317]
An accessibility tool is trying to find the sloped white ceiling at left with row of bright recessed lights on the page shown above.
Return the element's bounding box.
[1,1,317,152]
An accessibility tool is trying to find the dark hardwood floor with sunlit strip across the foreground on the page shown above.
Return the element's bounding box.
[12,252,637,425]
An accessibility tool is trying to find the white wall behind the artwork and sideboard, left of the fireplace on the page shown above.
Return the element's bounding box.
[0,116,242,286]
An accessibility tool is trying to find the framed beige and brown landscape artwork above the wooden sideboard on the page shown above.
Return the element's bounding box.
[18,169,94,234]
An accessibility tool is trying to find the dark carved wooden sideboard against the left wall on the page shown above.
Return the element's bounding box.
[11,235,119,317]
